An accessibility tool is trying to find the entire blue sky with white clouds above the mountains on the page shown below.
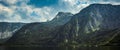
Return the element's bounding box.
[0,0,120,23]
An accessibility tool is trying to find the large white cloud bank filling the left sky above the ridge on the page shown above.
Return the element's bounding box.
[0,0,55,23]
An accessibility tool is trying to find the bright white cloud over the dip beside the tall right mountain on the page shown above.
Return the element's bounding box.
[60,0,120,14]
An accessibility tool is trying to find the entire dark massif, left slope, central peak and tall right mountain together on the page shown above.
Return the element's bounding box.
[6,4,120,46]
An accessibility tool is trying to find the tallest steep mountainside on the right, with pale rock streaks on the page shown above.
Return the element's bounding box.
[56,4,120,46]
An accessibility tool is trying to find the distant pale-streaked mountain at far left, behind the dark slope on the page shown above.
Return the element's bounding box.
[0,22,25,43]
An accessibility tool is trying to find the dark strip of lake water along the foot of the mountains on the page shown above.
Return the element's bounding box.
[0,46,120,50]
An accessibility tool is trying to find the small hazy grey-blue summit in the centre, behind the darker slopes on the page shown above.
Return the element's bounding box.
[50,12,73,25]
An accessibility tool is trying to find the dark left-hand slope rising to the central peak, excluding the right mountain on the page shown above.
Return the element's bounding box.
[5,12,72,45]
